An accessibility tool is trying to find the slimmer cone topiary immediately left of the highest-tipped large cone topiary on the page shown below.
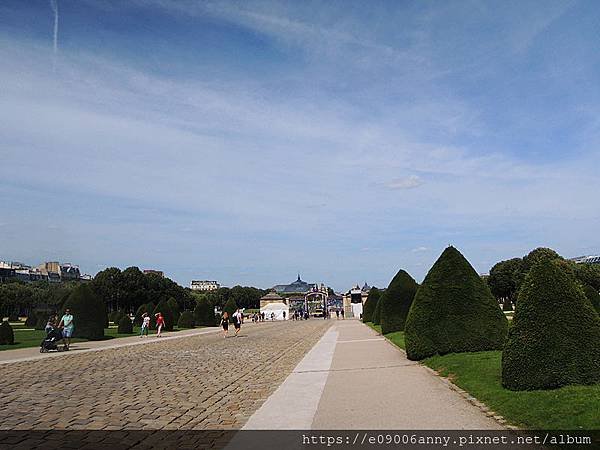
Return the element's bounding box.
[379,270,419,334]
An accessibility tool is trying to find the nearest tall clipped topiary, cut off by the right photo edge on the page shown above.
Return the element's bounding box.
[502,260,600,390]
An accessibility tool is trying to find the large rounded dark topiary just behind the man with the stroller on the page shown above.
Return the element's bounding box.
[59,283,106,340]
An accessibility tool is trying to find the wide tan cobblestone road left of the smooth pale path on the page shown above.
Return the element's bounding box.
[0,320,330,430]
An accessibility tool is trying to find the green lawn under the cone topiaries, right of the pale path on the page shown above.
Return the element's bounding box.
[366,322,600,430]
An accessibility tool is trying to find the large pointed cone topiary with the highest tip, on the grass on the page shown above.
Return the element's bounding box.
[404,247,508,360]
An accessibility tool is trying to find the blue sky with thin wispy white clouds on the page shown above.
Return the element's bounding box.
[0,0,600,290]
